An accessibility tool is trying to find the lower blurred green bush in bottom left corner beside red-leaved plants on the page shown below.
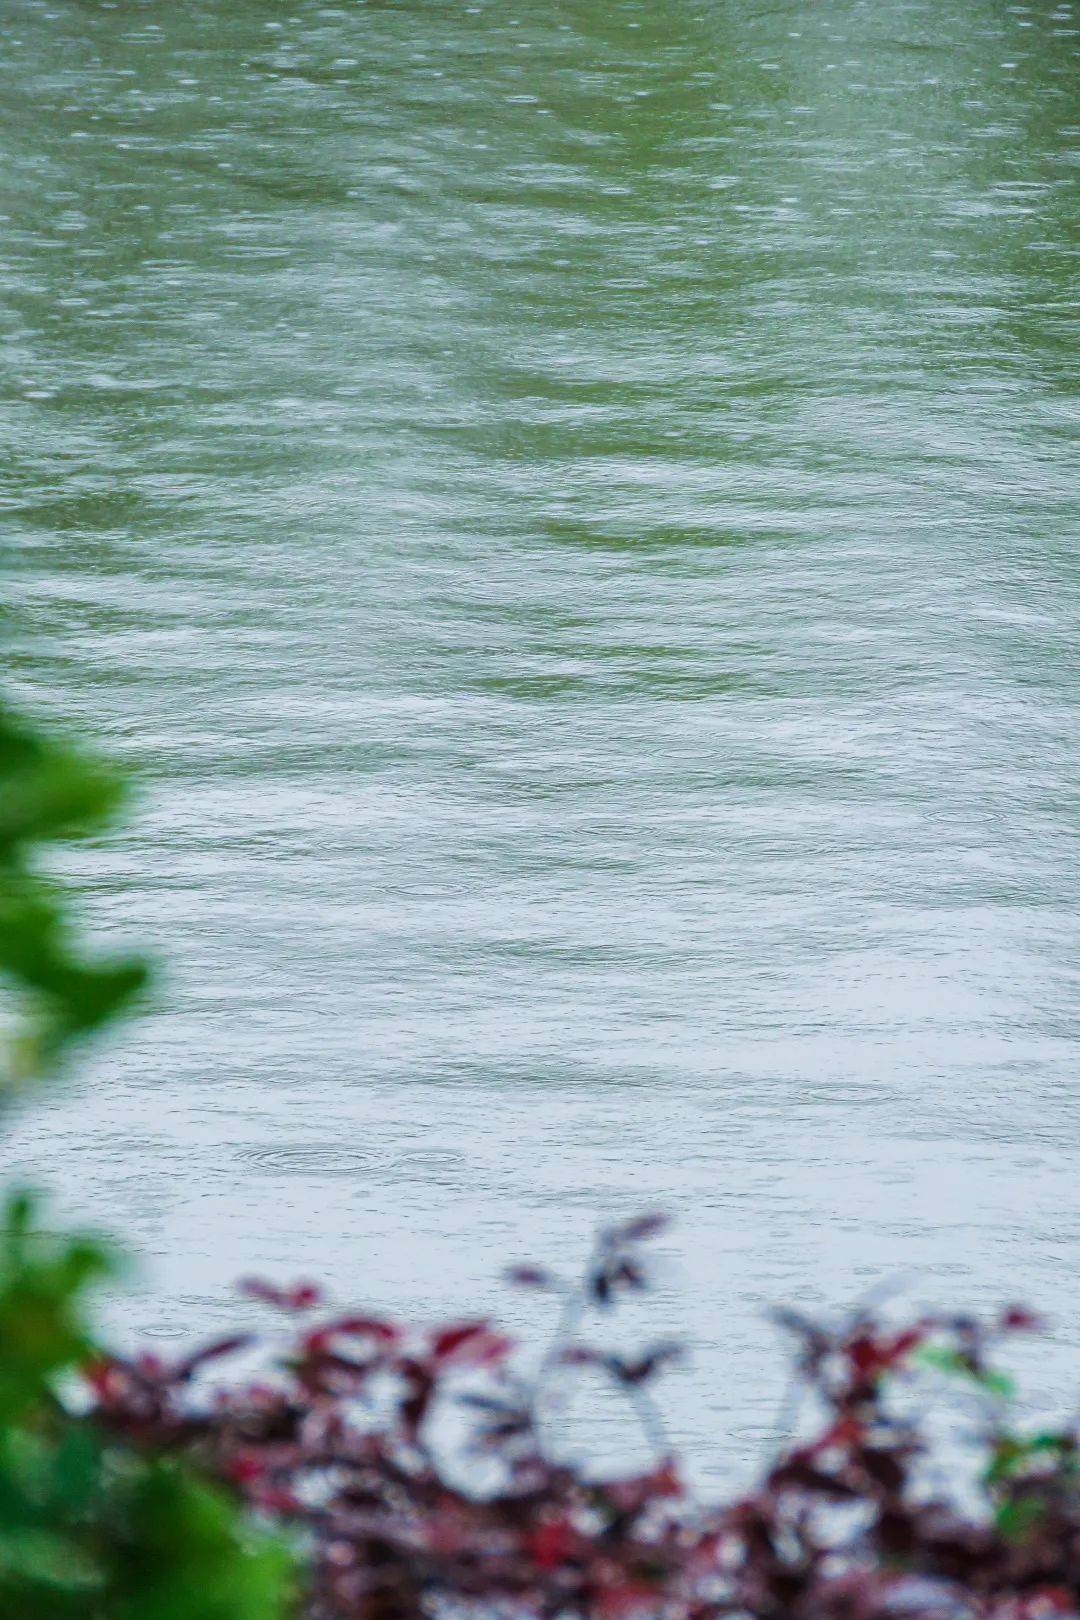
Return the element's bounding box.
[0,1194,290,1620]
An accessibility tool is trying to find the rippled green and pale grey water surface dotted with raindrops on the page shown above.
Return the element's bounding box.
[0,0,1080,1466]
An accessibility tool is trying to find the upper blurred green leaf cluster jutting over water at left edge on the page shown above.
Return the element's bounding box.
[0,703,147,1082]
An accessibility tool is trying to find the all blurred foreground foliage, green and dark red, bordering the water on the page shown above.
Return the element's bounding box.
[0,699,1080,1620]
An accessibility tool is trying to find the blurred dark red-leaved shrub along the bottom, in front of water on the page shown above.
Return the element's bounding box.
[87,1215,1080,1620]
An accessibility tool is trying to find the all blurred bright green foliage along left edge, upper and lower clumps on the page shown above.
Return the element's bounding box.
[0,705,293,1620]
